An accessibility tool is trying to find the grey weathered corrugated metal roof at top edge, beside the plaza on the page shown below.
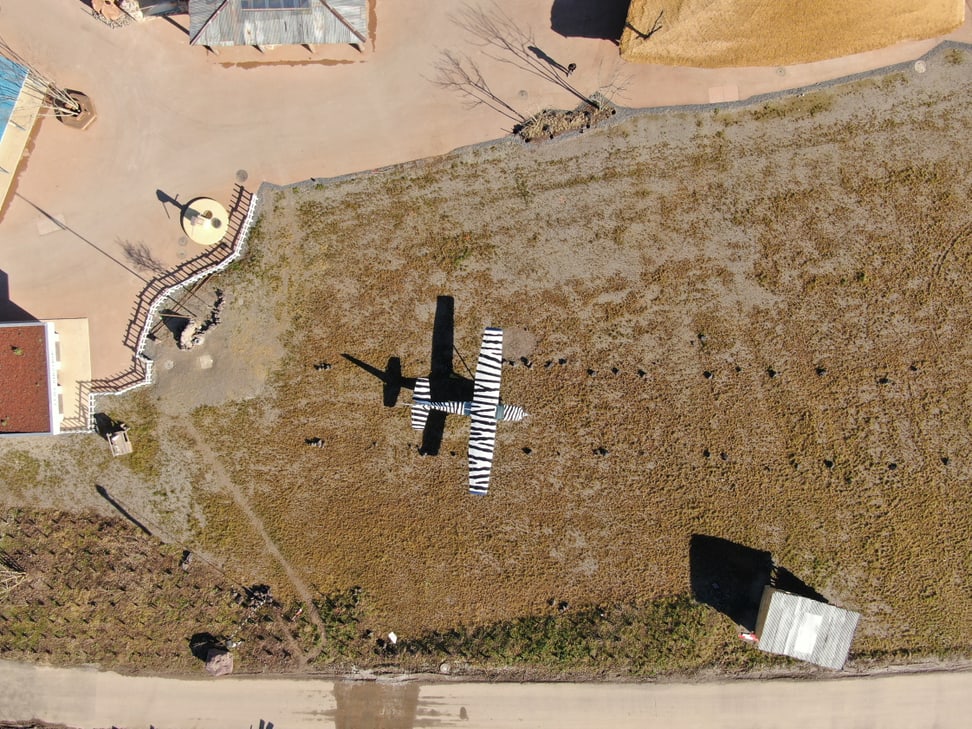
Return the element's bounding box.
[189,0,368,46]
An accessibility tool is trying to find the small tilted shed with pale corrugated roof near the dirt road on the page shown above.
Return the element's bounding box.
[756,587,861,670]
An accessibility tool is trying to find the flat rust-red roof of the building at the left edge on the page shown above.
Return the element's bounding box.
[0,322,51,433]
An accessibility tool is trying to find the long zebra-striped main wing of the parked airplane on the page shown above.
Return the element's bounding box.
[469,327,503,496]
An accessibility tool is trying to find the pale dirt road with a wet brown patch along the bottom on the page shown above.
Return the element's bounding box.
[0,662,972,729]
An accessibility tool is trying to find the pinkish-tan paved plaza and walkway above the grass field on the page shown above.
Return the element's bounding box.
[0,0,972,378]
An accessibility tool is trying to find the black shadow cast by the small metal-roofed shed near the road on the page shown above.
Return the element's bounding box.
[689,534,827,631]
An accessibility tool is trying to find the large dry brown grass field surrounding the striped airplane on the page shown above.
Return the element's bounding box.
[0,50,972,675]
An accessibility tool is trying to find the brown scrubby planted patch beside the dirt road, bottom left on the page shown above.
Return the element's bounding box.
[0,509,313,672]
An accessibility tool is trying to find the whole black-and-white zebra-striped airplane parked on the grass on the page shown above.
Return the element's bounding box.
[412,327,527,496]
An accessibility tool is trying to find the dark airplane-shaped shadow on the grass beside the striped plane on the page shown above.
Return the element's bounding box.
[341,296,473,456]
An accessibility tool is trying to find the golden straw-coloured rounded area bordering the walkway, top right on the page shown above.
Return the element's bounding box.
[621,0,965,68]
